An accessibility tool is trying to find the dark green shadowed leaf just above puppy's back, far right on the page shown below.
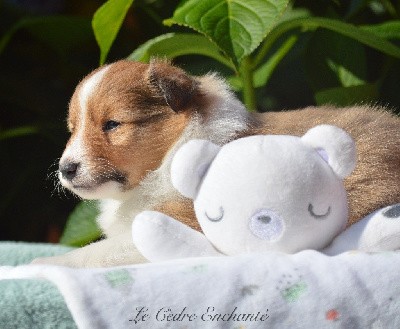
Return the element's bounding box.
[314,84,378,106]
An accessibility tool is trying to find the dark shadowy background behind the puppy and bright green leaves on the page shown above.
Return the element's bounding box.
[0,0,400,242]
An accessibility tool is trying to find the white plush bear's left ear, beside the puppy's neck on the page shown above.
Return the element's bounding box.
[171,139,221,199]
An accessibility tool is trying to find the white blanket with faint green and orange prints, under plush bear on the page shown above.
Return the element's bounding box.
[0,250,400,329]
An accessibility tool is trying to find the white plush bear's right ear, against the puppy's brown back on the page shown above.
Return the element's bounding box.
[301,125,357,178]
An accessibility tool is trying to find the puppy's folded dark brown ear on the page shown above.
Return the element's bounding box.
[148,60,198,112]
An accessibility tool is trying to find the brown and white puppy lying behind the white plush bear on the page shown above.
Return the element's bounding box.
[34,61,400,267]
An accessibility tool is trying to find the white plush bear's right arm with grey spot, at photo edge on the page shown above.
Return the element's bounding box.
[323,204,400,255]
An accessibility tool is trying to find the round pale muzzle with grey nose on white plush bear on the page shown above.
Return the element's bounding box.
[249,209,284,241]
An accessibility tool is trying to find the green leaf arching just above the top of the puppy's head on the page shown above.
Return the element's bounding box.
[128,33,235,70]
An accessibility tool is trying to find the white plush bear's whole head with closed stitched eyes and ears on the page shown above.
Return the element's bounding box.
[171,125,356,255]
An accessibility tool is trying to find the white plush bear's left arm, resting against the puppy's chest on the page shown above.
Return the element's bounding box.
[132,211,222,262]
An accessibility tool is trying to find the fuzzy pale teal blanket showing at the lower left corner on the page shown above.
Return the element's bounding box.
[0,241,77,329]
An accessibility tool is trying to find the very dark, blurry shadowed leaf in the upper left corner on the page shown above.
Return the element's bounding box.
[0,16,93,56]
